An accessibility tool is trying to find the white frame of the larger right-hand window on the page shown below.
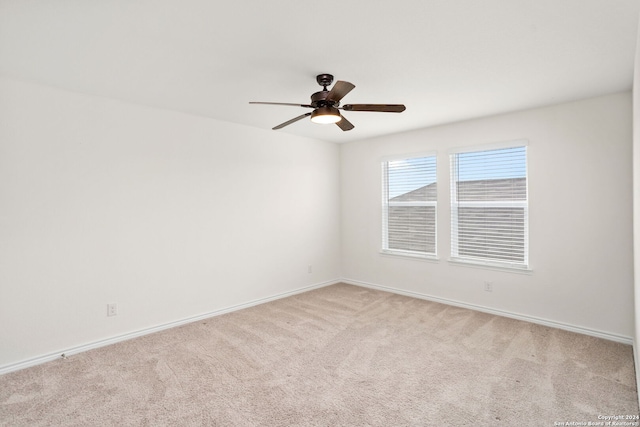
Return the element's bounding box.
[448,140,531,272]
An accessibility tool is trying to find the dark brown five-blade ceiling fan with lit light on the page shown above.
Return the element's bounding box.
[249,74,405,131]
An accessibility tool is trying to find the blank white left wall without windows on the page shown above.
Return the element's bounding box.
[0,79,340,370]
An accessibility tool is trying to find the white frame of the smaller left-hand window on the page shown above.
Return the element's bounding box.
[380,151,438,260]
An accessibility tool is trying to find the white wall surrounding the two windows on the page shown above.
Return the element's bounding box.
[341,93,634,342]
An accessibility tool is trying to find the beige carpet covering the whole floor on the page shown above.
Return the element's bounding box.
[0,284,638,426]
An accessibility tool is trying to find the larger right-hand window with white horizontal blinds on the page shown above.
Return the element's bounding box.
[451,142,529,269]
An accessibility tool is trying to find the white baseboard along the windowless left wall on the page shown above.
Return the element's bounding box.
[0,279,341,375]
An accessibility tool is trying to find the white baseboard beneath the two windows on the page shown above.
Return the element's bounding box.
[342,277,635,348]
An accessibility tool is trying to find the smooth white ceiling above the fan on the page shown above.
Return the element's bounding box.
[0,0,640,142]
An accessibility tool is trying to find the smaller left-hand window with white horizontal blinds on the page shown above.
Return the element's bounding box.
[382,155,437,257]
